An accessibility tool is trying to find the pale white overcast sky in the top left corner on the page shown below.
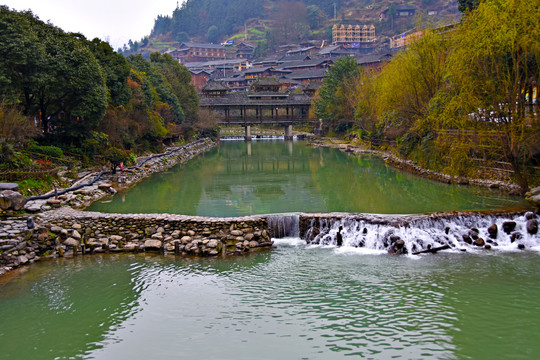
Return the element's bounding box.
[0,0,184,50]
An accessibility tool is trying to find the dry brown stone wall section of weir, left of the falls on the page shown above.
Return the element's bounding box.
[37,207,272,256]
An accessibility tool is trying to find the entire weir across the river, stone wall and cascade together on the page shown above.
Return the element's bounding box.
[0,207,540,275]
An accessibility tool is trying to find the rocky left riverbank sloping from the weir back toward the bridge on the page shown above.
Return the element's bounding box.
[0,139,217,275]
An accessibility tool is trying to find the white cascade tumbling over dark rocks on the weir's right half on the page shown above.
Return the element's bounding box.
[300,212,540,254]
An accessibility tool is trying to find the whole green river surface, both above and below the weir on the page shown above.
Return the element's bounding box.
[0,142,540,360]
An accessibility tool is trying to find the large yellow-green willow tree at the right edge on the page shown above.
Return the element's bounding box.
[448,0,540,191]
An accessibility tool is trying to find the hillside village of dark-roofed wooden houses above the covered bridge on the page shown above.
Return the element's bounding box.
[141,1,457,95]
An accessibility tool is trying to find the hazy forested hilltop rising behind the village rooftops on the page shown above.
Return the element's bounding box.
[142,0,459,51]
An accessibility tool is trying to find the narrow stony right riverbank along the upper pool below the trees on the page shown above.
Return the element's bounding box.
[312,139,521,195]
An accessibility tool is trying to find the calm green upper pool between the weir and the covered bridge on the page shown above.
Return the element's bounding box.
[89,141,527,217]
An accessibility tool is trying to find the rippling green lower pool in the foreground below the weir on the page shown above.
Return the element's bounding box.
[0,245,540,360]
